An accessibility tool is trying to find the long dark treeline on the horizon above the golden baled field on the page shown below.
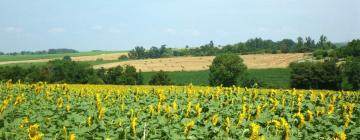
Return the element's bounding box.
[128,35,336,59]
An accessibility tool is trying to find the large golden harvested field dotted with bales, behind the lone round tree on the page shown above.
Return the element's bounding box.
[94,53,311,72]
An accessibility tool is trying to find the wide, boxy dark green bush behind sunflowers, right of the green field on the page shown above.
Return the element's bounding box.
[289,60,342,90]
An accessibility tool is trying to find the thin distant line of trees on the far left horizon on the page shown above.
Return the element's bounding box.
[0,48,79,55]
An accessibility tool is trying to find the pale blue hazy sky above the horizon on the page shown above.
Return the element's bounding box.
[0,0,360,52]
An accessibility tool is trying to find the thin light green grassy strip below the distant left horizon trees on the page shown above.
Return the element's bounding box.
[0,51,125,62]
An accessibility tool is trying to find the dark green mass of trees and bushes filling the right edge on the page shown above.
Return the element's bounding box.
[290,39,360,90]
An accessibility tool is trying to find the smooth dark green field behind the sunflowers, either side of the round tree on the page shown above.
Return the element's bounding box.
[143,68,290,88]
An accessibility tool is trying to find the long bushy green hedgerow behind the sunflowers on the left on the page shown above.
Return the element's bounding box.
[0,59,143,85]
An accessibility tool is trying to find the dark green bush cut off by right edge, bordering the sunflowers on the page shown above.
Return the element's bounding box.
[344,58,360,90]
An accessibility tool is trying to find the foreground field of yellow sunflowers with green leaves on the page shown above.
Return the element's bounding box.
[0,82,360,140]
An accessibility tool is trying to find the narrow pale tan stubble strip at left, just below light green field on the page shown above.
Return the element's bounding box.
[0,52,127,65]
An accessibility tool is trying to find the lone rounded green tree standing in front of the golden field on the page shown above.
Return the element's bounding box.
[209,54,247,87]
